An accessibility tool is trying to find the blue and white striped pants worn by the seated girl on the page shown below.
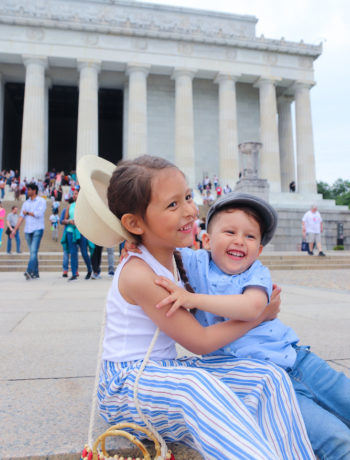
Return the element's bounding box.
[98,356,315,460]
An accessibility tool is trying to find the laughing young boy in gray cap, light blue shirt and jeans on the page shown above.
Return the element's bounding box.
[157,193,350,460]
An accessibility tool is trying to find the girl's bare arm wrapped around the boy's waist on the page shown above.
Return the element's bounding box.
[119,257,279,355]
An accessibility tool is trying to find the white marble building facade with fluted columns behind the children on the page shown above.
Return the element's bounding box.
[0,0,322,206]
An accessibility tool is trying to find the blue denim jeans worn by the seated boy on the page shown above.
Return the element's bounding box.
[288,347,350,460]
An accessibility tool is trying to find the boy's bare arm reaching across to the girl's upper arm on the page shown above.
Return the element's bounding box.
[155,277,268,321]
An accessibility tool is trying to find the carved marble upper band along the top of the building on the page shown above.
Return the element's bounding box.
[0,0,322,59]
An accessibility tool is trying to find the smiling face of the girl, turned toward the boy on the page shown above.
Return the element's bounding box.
[141,168,196,255]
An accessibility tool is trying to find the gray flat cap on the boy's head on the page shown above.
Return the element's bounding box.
[206,192,278,246]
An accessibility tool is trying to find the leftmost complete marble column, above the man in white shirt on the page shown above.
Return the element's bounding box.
[20,56,47,181]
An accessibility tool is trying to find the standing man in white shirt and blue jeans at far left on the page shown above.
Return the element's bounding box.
[11,182,46,280]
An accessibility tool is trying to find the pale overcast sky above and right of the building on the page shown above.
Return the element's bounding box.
[143,0,350,184]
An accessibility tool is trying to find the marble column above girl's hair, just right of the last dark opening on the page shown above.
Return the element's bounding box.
[127,64,150,159]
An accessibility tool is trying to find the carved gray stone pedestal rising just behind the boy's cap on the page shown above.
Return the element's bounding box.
[234,142,270,201]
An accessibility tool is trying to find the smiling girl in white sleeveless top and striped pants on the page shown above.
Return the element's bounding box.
[78,156,314,460]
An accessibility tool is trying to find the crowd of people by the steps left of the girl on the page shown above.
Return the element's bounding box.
[0,169,115,281]
